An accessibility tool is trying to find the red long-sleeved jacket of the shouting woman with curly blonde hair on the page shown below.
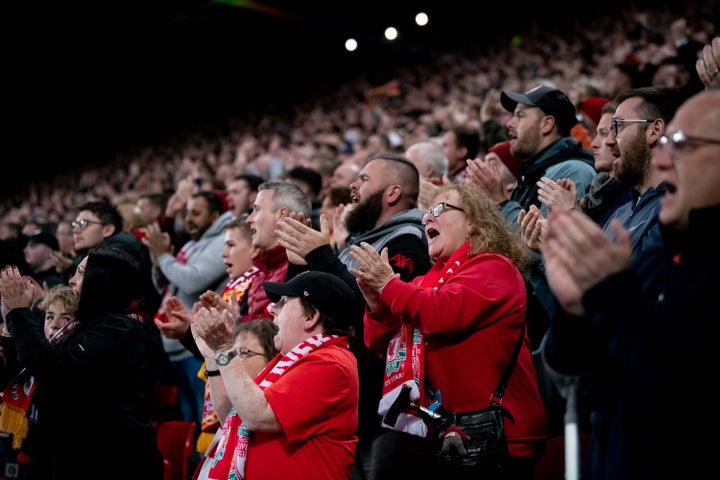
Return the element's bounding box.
[365,243,547,456]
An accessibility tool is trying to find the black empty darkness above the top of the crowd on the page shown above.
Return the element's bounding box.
[8,0,684,188]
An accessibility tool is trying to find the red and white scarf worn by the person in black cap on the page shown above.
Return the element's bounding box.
[197,334,349,480]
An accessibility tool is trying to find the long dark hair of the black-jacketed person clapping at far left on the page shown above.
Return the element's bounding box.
[76,246,142,322]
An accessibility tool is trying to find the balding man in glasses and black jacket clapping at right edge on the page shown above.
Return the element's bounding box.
[541,82,720,480]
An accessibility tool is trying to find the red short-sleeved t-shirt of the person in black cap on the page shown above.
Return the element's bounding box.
[245,345,359,480]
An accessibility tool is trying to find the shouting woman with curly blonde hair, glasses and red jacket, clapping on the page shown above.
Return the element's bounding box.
[351,183,547,480]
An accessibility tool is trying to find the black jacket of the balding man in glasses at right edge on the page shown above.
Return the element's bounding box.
[544,206,720,480]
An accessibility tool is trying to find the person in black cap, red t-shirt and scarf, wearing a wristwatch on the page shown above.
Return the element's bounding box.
[192,271,360,479]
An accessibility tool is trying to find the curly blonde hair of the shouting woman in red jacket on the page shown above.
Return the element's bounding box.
[430,183,531,276]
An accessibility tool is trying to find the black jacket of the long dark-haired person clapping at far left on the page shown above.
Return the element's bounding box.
[7,308,163,480]
